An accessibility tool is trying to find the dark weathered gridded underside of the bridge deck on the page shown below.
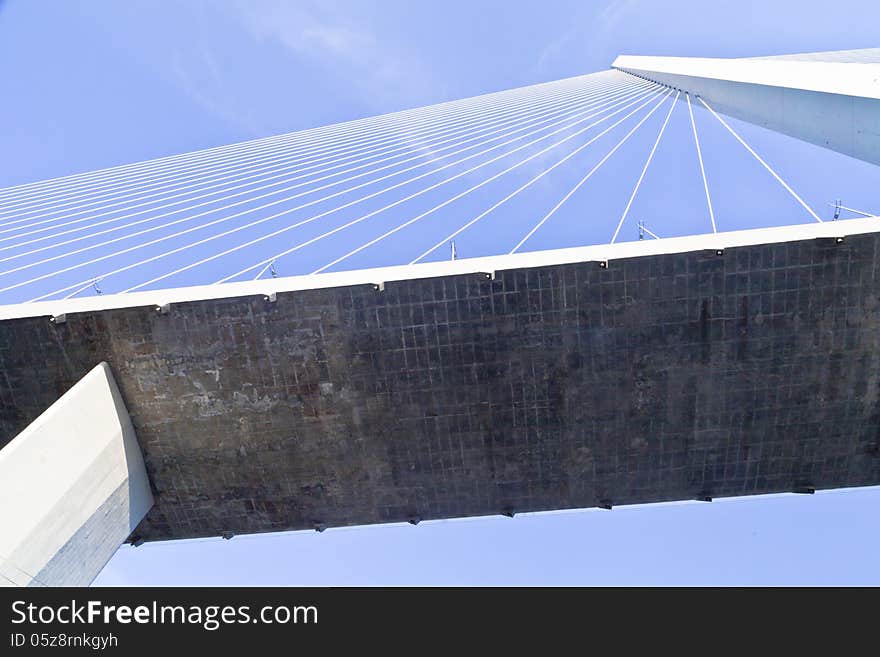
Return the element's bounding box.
[0,234,880,540]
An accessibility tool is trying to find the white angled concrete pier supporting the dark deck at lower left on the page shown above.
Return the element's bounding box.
[0,363,153,586]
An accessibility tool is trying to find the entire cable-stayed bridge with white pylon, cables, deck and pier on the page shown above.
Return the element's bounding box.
[0,49,880,585]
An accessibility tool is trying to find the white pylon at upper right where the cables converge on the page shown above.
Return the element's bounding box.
[612,55,880,164]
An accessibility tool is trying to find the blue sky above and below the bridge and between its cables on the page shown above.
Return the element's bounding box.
[0,0,880,584]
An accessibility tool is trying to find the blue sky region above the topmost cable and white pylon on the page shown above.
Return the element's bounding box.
[0,0,880,186]
